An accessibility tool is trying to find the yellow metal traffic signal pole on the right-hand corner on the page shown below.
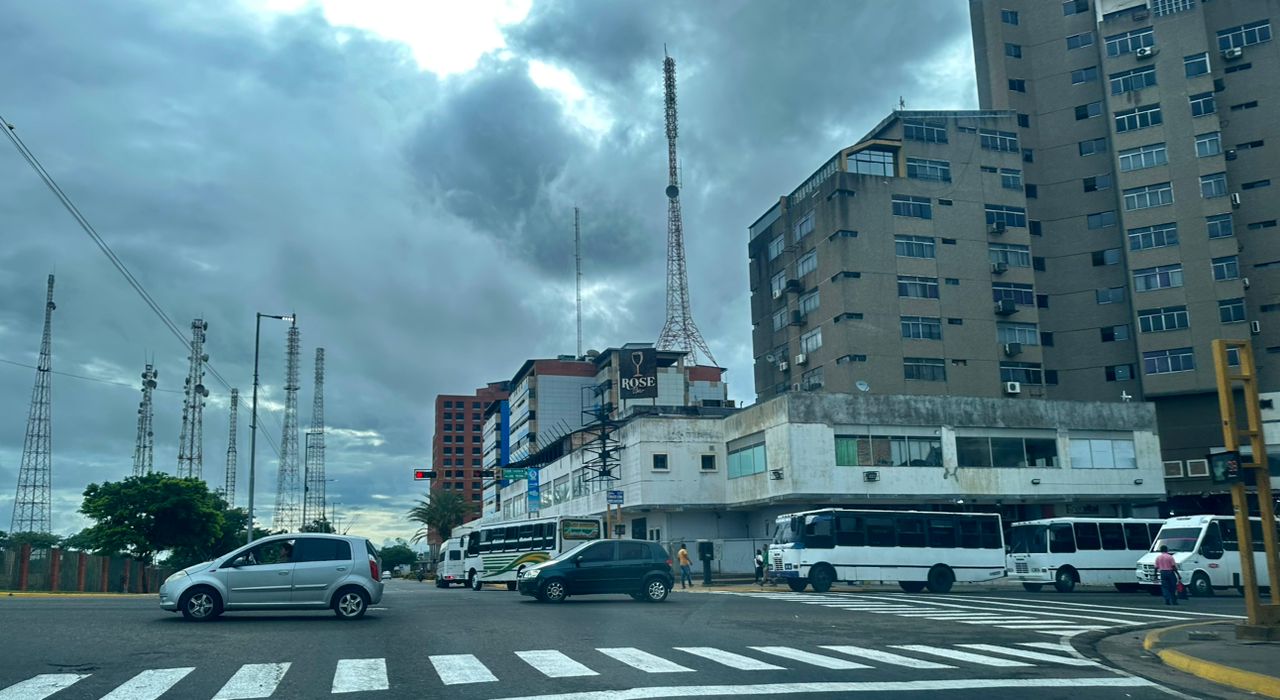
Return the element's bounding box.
[1213,338,1280,640]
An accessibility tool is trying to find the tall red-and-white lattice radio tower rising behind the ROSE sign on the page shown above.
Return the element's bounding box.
[658,50,716,365]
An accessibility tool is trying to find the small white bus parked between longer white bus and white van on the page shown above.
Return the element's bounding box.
[1005,518,1165,593]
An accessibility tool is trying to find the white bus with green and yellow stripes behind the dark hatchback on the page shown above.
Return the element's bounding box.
[462,517,602,591]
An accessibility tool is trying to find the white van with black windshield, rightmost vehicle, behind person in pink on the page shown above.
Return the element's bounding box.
[1134,516,1280,595]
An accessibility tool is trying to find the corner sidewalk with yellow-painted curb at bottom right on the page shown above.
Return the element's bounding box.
[1142,621,1280,697]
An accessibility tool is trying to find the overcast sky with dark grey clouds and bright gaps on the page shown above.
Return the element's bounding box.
[0,0,977,541]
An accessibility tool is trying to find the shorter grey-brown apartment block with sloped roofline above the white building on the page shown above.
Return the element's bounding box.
[748,111,1044,402]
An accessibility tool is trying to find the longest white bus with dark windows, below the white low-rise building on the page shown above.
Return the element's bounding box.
[767,508,1005,593]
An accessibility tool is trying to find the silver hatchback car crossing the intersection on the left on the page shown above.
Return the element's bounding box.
[160,532,383,621]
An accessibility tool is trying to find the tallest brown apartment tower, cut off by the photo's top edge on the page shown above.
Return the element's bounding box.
[970,0,1280,504]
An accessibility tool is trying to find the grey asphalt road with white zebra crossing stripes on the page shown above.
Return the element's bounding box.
[0,580,1243,700]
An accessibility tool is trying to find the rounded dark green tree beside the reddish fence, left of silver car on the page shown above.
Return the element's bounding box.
[81,472,225,564]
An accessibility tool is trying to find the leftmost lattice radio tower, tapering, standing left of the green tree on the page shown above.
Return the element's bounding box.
[9,275,56,535]
